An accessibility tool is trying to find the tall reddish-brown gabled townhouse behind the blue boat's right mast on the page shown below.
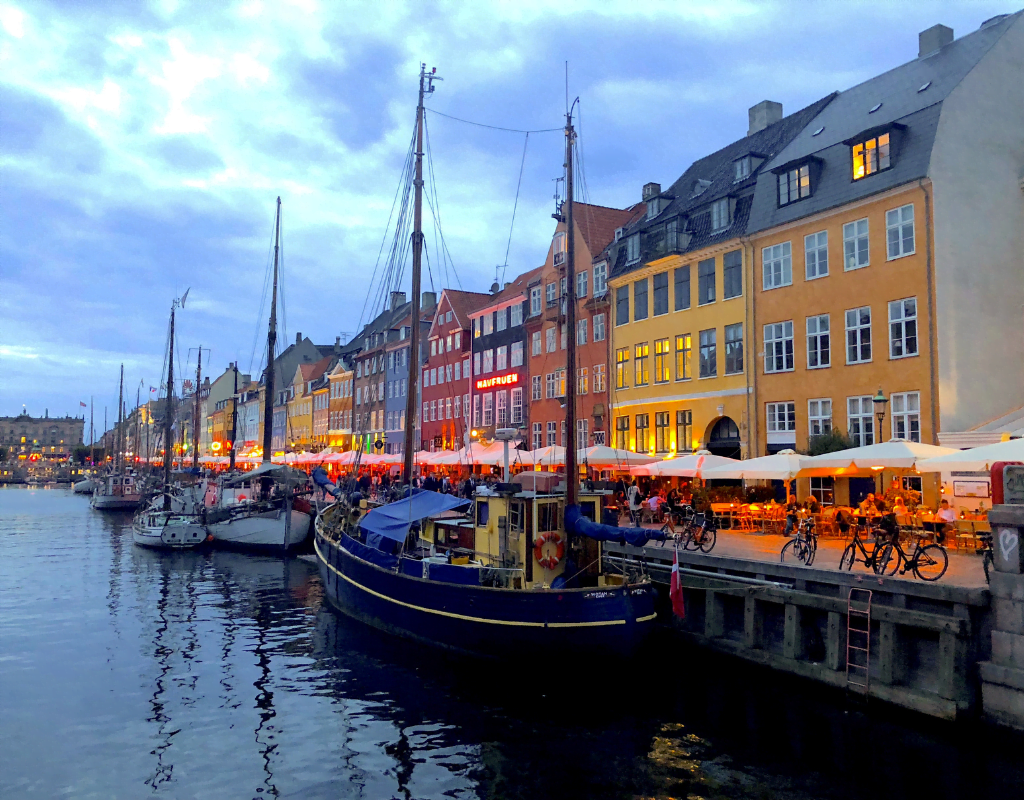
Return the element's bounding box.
[525,203,640,449]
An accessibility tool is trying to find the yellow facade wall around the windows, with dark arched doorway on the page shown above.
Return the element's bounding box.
[608,239,753,457]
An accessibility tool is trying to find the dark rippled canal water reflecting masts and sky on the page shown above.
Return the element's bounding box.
[0,488,1024,800]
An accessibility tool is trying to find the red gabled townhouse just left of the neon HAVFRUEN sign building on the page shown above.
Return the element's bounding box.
[420,289,492,451]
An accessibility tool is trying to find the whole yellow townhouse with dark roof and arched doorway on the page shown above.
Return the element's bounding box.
[604,96,831,458]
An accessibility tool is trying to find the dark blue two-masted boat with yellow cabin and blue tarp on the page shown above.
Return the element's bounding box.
[313,67,656,658]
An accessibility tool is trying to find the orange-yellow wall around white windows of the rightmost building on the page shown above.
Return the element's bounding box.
[749,185,938,455]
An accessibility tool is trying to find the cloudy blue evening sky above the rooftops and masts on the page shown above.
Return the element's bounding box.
[0,0,1018,435]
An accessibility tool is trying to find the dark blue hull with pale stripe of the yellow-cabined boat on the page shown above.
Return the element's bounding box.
[314,534,656,660]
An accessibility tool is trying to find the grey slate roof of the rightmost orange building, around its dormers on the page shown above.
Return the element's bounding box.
[748,11,1024,234]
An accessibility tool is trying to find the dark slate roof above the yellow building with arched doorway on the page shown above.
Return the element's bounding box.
[607,94,835,277]
